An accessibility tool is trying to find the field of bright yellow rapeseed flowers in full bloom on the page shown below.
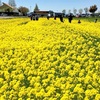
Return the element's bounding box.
[0,18,100,100]
